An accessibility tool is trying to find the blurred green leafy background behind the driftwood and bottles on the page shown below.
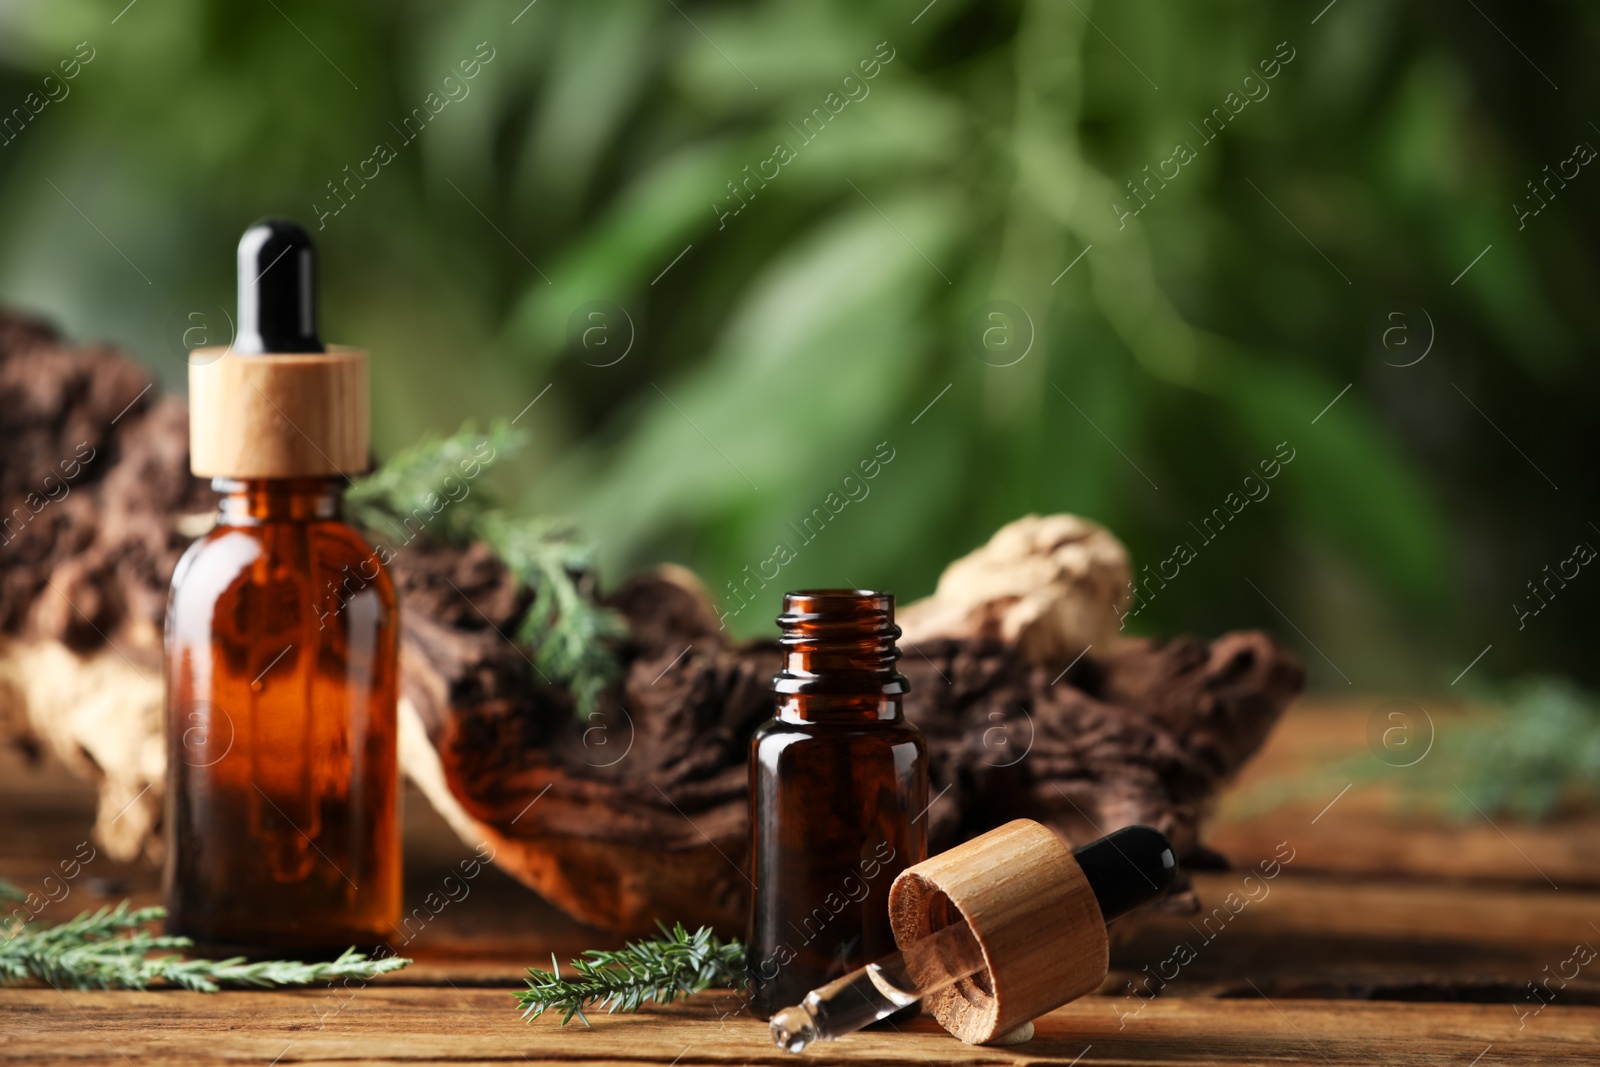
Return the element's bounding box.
[0,0,1600,691]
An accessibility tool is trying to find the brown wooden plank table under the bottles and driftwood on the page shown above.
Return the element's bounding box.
[0,702,1600,1067]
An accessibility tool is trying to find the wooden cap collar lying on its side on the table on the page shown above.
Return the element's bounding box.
[890,819,1110,1045]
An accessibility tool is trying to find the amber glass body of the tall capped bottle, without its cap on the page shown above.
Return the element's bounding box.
[166,478,400,950]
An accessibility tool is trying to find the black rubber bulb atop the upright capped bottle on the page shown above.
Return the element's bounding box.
[234,219,323,355]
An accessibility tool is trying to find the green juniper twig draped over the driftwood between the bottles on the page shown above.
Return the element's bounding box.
[346,424,627,717]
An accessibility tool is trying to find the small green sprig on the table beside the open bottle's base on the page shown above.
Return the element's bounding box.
[517,923,746,1025]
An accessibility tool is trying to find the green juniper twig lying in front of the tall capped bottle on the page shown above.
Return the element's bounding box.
[0,880,411,993]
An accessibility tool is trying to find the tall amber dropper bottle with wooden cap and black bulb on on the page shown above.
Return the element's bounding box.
[165,221,400,953]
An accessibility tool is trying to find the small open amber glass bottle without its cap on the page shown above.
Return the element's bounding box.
[747,589,928,1017]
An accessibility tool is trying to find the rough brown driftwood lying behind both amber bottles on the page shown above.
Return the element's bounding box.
[0,317,1304,933]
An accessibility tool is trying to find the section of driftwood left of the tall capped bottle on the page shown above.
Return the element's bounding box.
[0,312,216,857]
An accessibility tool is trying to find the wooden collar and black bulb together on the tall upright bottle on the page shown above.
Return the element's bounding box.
[189,219,370,478]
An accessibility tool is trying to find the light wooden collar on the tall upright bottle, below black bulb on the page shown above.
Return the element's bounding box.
[189,346,370,478]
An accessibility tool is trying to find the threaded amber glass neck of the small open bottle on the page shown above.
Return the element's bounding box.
[773,589,906,723]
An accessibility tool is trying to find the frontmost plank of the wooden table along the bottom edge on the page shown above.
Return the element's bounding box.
[0,984,1600,1067]
